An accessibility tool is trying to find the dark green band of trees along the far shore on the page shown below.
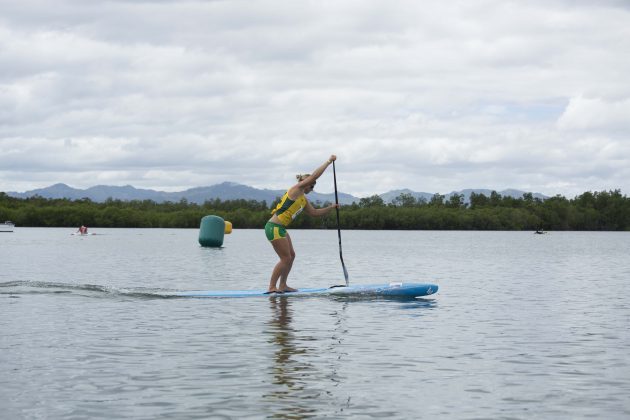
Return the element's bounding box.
[0,190,630,231]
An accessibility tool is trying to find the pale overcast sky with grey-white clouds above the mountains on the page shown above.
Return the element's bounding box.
[0,0,630,198]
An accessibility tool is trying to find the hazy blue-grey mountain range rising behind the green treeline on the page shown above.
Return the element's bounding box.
[6,182,548,204]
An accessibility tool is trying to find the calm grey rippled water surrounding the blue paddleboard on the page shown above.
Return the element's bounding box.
[0,228,630,419]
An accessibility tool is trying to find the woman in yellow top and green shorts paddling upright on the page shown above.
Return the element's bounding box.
[265,155,338,293]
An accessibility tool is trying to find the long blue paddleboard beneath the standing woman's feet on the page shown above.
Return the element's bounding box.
[174,283,438,298]
